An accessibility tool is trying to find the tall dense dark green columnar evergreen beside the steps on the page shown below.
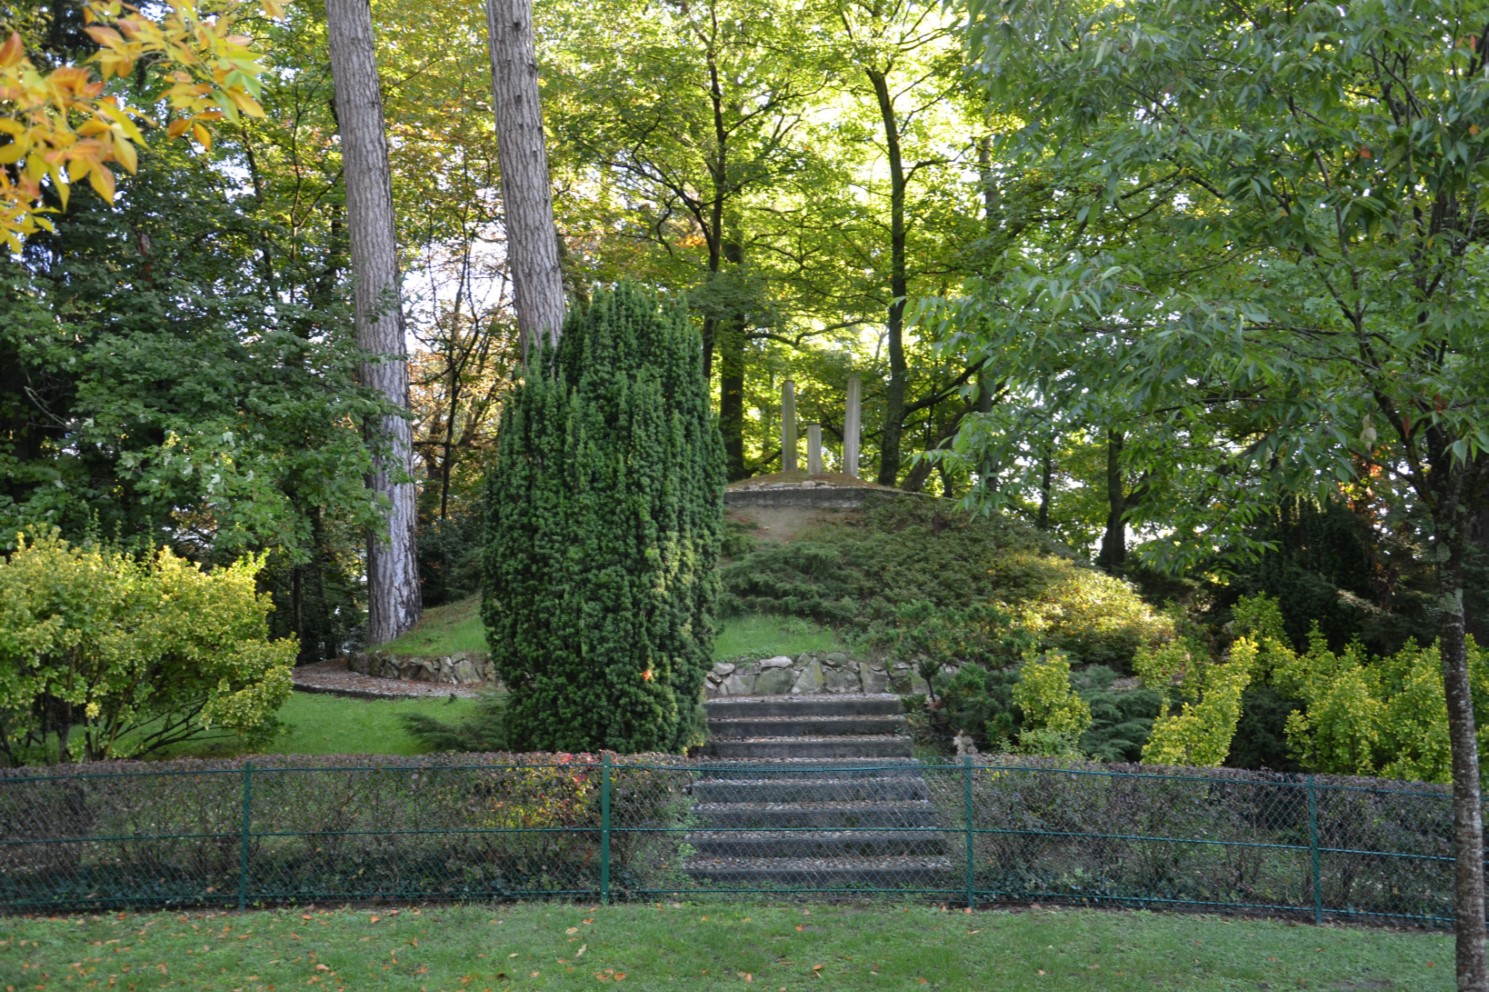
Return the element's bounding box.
[481,286,724,752]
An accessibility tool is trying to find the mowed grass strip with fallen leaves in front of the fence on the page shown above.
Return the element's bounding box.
[0,903,1453,992]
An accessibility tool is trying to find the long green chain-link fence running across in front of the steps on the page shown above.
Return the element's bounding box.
[0,755,1453,925]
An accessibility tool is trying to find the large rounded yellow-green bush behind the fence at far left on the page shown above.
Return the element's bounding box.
[0,533,296,764]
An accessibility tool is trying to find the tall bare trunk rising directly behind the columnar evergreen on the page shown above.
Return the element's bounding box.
[485,0,564,357]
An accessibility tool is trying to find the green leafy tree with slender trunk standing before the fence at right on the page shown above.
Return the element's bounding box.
[966,0,1489,971]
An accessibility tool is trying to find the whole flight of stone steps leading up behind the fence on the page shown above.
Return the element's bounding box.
[686,694,950,891]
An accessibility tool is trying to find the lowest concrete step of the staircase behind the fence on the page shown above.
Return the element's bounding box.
[683,856,956,889]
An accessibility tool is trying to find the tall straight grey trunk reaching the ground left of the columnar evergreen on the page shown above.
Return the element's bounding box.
[326,0,421,643]
